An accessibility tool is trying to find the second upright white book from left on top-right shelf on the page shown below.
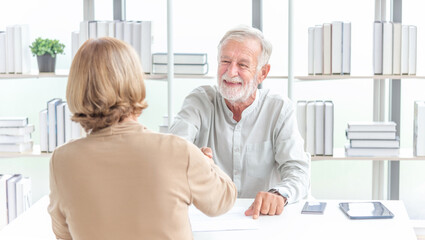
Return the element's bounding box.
[382,22,393,75]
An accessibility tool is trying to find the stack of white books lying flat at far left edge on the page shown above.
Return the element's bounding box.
[0,117,34,152]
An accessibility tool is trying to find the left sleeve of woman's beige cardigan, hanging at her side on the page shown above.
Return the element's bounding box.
[47,153,72,239]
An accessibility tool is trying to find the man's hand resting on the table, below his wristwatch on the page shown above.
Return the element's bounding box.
[245,192,286,219]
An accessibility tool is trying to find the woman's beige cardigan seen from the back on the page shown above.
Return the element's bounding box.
[48,122,237,240]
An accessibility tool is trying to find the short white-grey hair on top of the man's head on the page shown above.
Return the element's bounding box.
[218,25,273,71]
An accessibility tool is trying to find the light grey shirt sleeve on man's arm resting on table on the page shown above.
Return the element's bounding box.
[273,101,311,203]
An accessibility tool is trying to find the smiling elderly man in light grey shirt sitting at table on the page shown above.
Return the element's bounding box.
[170,26,310,218]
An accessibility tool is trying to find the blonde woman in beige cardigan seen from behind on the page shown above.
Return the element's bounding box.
[48,38,236,240]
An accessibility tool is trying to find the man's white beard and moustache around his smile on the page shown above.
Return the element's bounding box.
[218,73,257,102]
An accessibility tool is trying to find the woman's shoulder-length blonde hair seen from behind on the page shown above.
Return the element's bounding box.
[66,37,147,132]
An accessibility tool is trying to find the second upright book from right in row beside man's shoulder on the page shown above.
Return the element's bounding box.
[314,101,325,155]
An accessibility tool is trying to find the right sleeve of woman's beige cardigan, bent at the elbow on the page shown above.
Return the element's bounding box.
[187,144,237,216]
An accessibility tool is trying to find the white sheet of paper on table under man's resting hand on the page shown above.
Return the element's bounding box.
[189,205,259,232]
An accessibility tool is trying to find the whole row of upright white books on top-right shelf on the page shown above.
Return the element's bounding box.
[373,21,417,75]
